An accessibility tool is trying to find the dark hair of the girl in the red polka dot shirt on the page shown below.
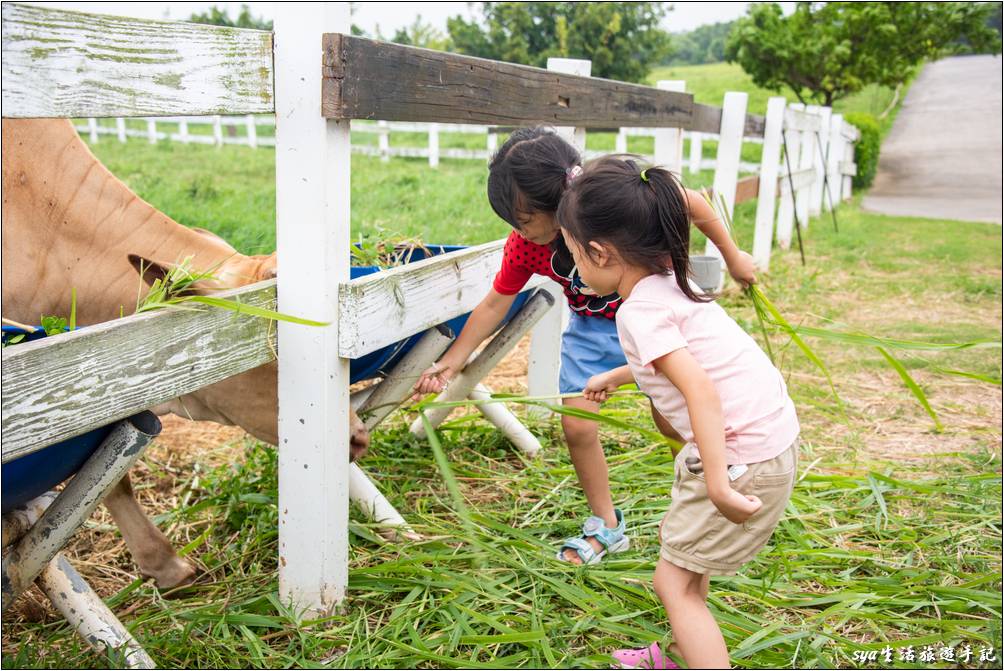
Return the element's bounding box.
[488,127,582,230]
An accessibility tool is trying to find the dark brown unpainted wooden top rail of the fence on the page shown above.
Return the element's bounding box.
[321,33,763,136]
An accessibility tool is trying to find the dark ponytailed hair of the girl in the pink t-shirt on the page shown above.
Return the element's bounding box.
[557,156,712,302]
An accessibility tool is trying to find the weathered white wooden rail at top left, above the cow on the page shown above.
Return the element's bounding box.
[2,2,275,118]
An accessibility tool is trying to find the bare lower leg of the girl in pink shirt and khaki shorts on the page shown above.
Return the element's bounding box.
[653,558,729,669]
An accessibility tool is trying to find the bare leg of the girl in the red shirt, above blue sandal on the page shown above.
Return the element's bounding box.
[561,398,617,564]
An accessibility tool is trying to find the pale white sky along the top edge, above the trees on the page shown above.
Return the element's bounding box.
[29,2,794,36]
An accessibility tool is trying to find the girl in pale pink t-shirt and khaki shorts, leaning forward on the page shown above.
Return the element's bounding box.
[557,157,799,668]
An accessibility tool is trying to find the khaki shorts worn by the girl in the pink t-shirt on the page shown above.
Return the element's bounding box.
[661,439,798,576]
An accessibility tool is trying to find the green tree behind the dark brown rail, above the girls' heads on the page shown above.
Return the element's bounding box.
[447,2,669,81]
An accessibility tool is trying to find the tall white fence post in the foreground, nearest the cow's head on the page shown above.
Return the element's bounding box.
[274,2,351,614]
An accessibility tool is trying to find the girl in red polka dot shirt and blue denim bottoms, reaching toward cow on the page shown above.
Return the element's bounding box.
[415,128,755,564]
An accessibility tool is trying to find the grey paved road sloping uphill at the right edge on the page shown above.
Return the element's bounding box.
[863,56,1002,224]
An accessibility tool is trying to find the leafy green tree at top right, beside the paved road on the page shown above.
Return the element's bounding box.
[726,2,1001,105]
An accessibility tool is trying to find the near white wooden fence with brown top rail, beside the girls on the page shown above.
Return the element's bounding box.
[0,3,856,613]
